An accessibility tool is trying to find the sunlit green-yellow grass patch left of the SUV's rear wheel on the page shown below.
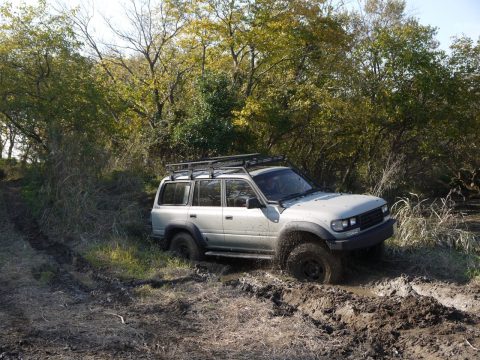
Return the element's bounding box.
[85,237,190,280]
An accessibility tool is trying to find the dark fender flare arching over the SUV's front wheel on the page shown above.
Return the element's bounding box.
[275,221,335,266]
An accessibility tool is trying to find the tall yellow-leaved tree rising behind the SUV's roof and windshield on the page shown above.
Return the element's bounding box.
[236,1,349,180]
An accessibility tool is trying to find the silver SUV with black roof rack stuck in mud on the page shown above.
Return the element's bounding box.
[152,154,395,283]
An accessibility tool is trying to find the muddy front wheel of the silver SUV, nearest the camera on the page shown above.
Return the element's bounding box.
[287,243,342,284]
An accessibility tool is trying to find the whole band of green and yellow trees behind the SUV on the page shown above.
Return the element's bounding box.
[0,0,480,245]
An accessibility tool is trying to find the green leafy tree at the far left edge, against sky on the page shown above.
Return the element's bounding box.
[0,2,115,170]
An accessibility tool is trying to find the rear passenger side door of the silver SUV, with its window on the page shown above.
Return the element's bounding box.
[187,179,224,248]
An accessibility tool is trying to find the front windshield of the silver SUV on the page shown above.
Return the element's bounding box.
[253,169,314,201]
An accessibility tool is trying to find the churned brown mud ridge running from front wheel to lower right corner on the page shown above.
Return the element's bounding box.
[229,276,480,358]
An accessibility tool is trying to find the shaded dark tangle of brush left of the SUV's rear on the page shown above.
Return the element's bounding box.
[21,168,150,243]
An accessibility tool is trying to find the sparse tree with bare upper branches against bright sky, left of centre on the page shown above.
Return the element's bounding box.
[74,0,192,160]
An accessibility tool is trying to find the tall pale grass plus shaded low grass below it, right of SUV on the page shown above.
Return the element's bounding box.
[378,194,480,281]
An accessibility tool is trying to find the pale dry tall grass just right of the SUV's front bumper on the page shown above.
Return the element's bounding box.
[392,194,480,254]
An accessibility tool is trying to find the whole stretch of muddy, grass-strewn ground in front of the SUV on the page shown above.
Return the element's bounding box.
[0,186,480,359]
